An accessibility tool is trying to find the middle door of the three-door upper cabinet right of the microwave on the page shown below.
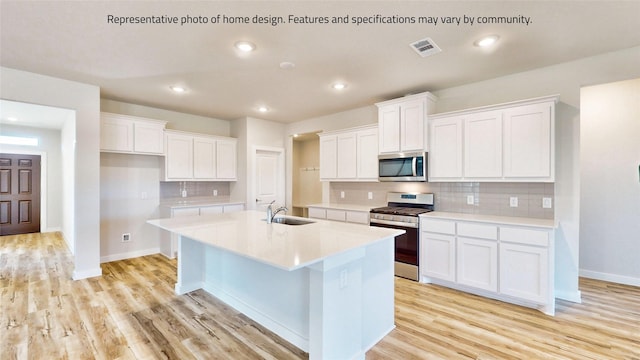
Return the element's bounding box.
[464,111,502,178]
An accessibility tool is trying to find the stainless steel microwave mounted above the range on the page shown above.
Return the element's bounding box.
[378,152,427,181]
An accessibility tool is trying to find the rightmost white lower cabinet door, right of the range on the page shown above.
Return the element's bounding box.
[500,242,549,304]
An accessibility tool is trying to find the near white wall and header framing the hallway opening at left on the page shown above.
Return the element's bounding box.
[0,67,102,279]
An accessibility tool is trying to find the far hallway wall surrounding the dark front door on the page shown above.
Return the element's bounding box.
[0,124,62,232]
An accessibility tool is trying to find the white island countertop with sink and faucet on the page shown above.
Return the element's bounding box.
[147,210,404,270]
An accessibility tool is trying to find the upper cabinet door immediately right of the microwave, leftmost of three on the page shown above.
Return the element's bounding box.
[429,117,463,180]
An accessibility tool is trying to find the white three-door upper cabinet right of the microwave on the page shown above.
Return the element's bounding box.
[429,96,558,182]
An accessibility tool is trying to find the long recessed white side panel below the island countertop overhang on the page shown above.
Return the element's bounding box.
[203,246,309,352]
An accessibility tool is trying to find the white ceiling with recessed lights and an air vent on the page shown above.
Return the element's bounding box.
[0,0,640,122]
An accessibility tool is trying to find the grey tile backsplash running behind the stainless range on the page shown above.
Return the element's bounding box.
[330,182,555,219]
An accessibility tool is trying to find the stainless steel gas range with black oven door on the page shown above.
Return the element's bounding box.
[369,192,433,281]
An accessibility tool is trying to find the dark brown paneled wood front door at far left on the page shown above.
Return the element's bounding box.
[0,154,40,235]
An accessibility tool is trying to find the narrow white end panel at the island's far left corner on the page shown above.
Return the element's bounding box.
[175,236,205,295]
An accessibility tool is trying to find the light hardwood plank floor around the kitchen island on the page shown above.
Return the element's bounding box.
[0,233,640,360]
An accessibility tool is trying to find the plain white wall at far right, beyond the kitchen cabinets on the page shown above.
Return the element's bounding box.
[580,78,640,286]
